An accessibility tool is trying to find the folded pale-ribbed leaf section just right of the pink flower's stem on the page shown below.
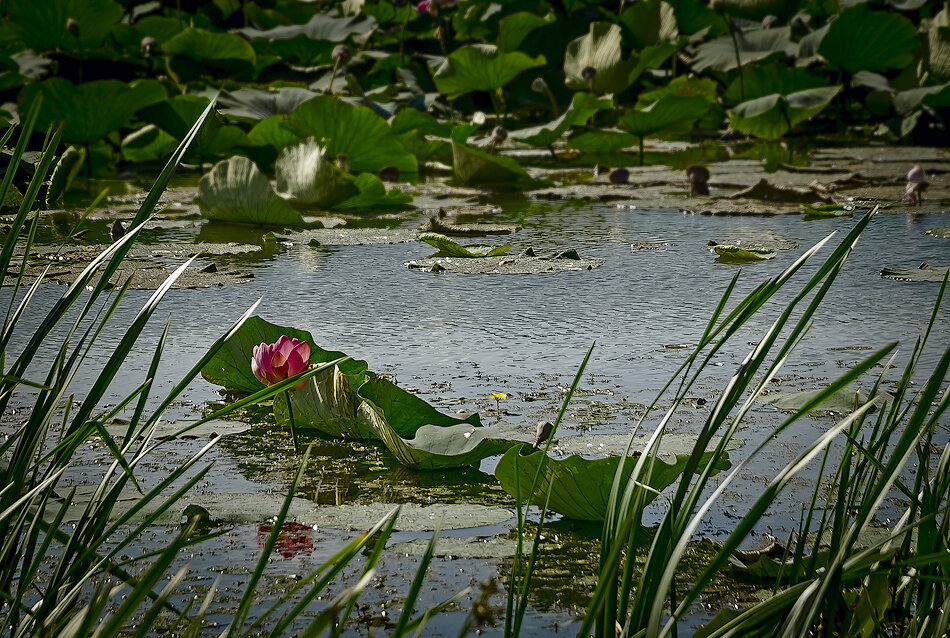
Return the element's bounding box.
[274,366,378,439]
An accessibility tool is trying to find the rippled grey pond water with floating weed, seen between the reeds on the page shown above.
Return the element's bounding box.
[4,192,950,635]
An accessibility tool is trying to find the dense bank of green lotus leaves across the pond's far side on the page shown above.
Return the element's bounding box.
[0,0,950,201]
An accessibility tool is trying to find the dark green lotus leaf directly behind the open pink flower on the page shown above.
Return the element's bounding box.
[201,316,367,396]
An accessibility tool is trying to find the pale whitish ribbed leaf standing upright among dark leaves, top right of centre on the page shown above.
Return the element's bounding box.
[564,22,636,94]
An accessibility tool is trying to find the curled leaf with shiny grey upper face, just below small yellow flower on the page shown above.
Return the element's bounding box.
[360,422,534,470]
